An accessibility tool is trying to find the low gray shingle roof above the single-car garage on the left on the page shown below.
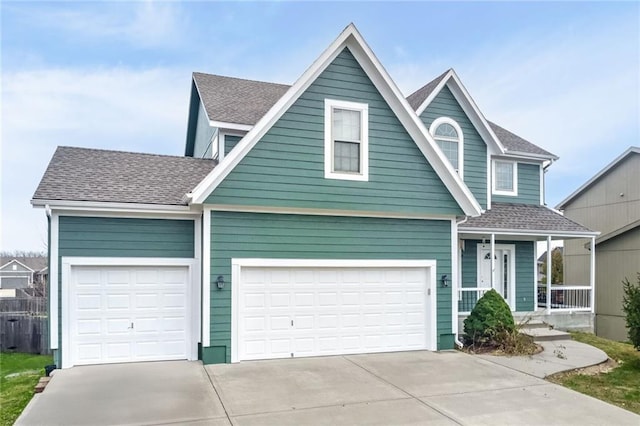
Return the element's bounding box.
[32,147,217,205]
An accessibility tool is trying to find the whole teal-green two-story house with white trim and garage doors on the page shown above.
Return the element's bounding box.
[32,25,597,368]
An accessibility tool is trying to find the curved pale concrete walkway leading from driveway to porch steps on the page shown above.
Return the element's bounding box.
[477,339,609,379]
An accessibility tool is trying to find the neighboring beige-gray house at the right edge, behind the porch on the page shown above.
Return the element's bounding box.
[557,147,640,340]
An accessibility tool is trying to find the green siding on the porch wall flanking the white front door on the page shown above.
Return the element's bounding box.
[462,240,536,312]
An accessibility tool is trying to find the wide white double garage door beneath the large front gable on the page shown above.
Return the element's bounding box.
[237,267,430,360]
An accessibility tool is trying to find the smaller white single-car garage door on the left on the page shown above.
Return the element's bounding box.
[69,266,189,365]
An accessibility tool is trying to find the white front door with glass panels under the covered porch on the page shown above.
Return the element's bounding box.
[478,244,515,310]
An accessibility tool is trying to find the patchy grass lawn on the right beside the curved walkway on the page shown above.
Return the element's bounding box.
[549,333,640,414]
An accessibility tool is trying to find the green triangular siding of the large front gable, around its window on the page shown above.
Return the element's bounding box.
[206,49,462,215]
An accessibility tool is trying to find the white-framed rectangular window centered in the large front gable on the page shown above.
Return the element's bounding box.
[324,99,369,181]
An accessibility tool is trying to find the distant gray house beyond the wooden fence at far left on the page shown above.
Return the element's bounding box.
[0,257,47,289]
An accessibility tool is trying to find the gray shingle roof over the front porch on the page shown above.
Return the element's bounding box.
[460,203,592,232]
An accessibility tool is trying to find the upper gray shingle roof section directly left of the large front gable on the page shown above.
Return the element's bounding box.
[193,72,291,125]
